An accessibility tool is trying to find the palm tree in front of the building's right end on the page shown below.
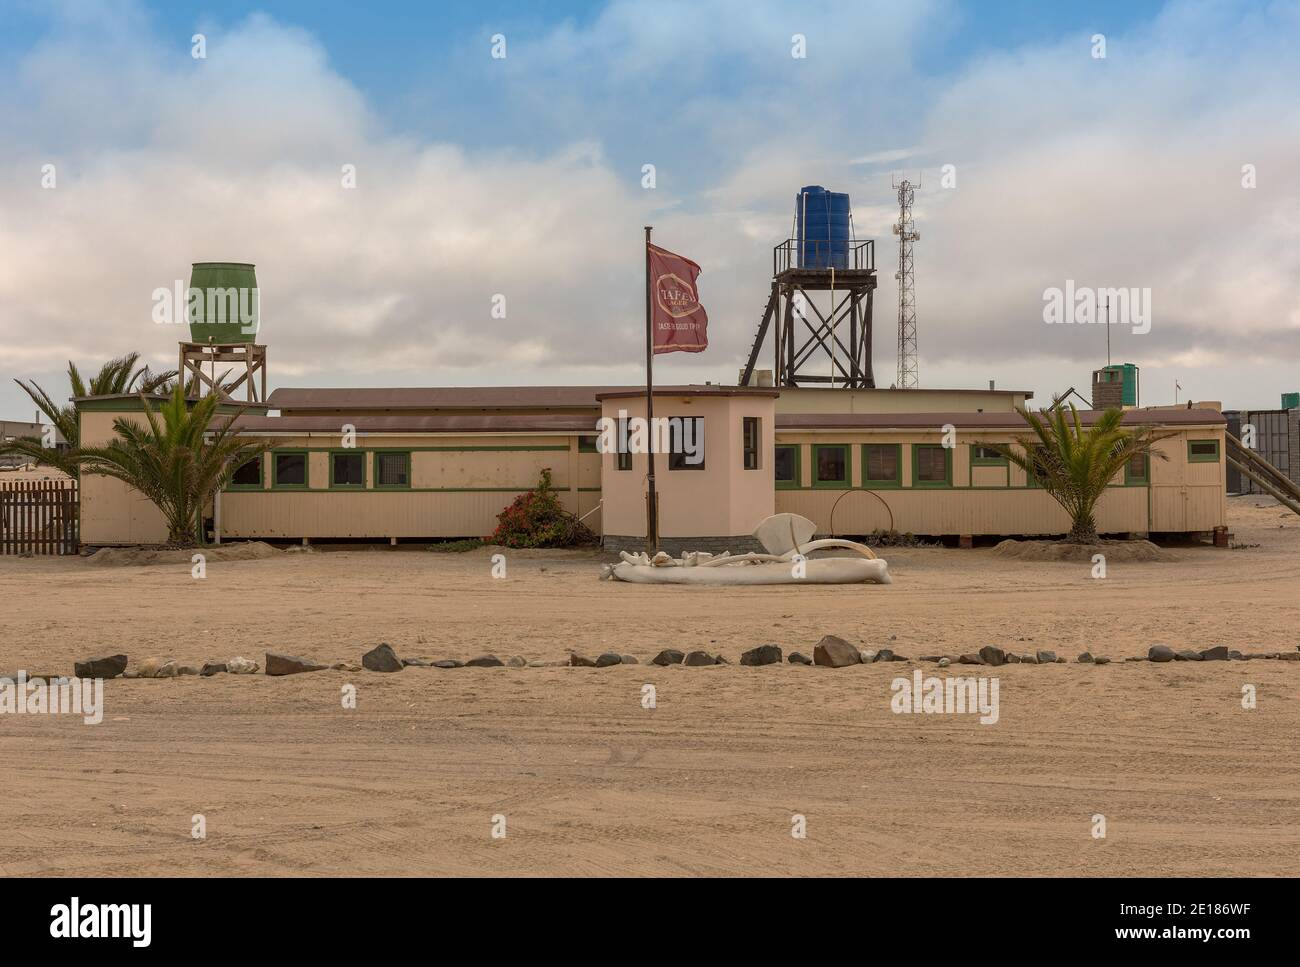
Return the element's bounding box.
[976,403,1174,543]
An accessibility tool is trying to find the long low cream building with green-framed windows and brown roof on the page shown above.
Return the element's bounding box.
[75,385,1227,550]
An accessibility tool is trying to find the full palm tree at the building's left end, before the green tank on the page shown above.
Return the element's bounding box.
[70,385,270,547]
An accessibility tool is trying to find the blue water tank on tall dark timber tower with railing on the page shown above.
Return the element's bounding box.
[740,185,876,389]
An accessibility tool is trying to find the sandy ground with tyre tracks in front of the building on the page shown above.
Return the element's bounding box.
[0,498,1300,875]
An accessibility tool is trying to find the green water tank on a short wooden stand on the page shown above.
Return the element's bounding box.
[179,263,267,403]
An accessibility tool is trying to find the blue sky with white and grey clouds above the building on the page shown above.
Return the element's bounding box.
[0,0,1300,419]
